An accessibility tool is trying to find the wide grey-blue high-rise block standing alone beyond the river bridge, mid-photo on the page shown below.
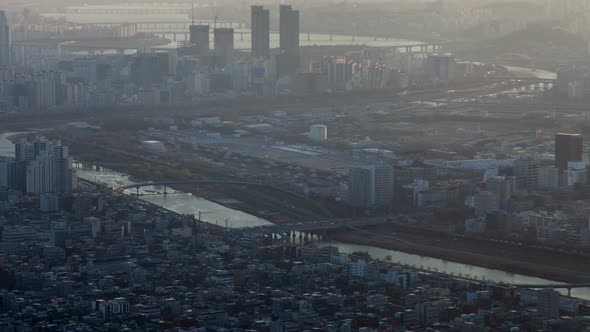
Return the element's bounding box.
[348,165,393,209]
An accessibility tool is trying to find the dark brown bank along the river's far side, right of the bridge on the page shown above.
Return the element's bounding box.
[330,225,590,283]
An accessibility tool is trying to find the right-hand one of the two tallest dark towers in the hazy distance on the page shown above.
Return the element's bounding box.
[277,5,300,77]
